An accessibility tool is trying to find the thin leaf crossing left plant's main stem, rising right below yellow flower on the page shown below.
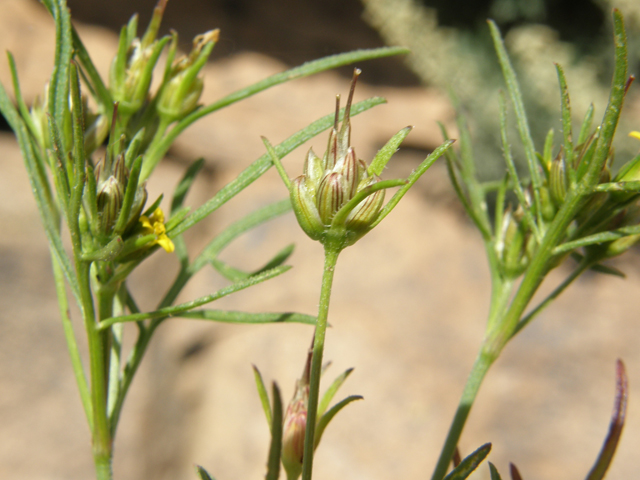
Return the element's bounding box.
[98,267,291,330]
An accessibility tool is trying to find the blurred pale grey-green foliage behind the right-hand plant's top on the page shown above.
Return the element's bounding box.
[362,0,640,179]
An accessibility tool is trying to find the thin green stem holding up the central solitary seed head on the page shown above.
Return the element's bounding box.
[302,245,340,480]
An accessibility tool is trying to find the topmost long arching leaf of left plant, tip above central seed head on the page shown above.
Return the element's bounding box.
[142,47,409,174]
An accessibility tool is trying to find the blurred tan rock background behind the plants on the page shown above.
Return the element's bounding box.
[0,0,640,480]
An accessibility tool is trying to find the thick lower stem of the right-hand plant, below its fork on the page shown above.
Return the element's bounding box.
[431,352,495,480]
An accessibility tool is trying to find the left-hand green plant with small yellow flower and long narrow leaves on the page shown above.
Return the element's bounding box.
[0,0,404,479]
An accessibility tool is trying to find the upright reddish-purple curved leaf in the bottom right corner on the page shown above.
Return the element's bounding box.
[586,360,629,480]
